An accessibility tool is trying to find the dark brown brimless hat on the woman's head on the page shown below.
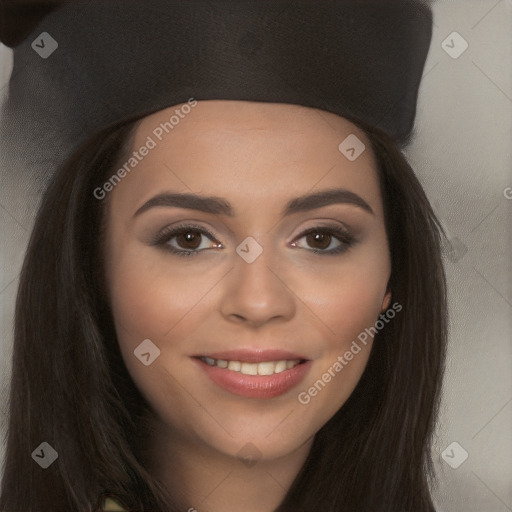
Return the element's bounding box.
[0,0,432,182]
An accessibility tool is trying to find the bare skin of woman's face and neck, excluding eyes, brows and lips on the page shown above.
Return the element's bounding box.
[105,100,391,512]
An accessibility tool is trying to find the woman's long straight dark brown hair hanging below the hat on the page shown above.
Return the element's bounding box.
[0,113,447,512]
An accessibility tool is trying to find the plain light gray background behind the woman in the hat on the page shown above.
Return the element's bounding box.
[0,0,512,512]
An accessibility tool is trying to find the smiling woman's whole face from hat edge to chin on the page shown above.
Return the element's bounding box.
[105,100,390,459]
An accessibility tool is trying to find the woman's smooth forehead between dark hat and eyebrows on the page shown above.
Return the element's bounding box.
[115,100,380,216]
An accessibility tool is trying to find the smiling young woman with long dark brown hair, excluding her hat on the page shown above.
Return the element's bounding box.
[0,2,446,512]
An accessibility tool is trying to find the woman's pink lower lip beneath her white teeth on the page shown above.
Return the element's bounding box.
[195,359,311,398]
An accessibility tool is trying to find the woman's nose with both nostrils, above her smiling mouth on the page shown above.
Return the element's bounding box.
[220,245,297,327]
